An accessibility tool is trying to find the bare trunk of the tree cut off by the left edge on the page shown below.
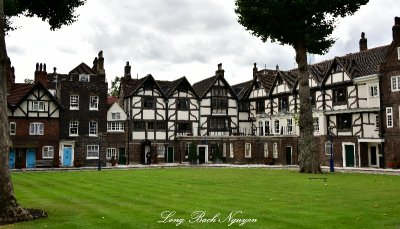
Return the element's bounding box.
[0,0,32,225]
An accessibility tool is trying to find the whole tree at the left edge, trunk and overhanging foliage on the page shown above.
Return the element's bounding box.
[0,0,85,225]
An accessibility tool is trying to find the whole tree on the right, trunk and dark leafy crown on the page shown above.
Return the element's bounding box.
[235,0,368,173]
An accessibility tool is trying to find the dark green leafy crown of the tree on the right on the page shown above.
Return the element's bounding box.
[235,0,368,54]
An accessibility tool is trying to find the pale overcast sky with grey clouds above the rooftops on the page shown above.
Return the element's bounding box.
[6,0,400,85]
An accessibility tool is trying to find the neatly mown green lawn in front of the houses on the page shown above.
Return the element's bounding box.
[5,168,400,228]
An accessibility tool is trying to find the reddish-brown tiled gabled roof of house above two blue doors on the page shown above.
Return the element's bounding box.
[7,82,63,109]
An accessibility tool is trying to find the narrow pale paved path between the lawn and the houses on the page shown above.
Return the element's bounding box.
[11,163,400,175]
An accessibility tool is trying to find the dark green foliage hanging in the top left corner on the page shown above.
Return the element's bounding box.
[4,0,86,31]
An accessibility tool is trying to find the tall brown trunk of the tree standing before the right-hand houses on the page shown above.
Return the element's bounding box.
[294,42,321,173]
